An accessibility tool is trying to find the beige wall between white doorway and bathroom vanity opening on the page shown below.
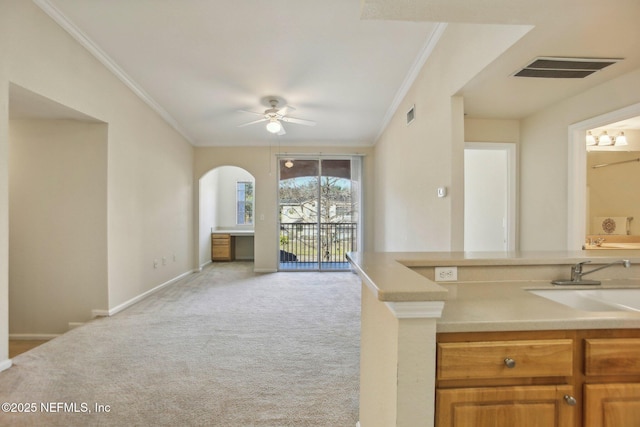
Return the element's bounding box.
[520,70,640,250]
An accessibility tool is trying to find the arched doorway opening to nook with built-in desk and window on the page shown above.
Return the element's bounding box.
[198,166,256,267]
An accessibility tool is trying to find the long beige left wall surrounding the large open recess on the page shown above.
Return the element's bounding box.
[0,0,196,362]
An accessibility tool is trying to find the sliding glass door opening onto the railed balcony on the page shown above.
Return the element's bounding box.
[278,157,360,270]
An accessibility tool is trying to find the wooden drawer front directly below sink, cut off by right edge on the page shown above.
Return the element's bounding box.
[584,338,640,375]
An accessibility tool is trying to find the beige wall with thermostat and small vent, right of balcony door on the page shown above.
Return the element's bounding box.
[374,24,526,251]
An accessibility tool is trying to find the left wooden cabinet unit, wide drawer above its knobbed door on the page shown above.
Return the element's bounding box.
[435,334,576,427]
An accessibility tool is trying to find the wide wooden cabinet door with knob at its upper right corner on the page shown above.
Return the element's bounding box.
[436,386,576,427]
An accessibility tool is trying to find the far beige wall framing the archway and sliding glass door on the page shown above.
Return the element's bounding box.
[194,146,374,272]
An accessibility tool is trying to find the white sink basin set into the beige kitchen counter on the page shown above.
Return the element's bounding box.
[529,289,640,311]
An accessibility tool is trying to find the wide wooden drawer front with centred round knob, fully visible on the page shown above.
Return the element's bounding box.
[437,339,573,380]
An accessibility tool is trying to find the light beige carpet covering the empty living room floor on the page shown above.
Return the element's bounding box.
[0,262,360,427]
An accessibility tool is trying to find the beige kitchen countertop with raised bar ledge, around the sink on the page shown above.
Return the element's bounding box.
[347,250,640,332]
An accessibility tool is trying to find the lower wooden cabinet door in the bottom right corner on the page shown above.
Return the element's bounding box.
[584,384,640,427]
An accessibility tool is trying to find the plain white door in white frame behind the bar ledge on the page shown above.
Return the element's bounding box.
[464,143,515,252]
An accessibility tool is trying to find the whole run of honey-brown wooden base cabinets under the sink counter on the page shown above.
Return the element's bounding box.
[435,329,640,427]
